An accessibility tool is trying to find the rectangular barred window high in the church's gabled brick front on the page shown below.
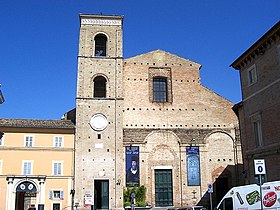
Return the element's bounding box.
[153,77,167,102]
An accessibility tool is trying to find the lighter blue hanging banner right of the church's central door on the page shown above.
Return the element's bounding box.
[186,146,200,186]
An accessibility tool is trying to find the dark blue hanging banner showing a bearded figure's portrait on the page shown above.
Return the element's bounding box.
[125,146,139,186]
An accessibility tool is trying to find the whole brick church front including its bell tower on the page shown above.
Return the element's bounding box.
[74,14,242,209]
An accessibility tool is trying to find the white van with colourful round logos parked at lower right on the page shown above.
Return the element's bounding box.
[215,181,280,210]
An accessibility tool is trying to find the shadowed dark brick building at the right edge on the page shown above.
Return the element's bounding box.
[231,22,280,183]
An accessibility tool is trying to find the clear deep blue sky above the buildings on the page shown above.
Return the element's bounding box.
[0,0,280,119]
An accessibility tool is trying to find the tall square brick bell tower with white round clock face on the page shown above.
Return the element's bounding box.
[74,14,124,209]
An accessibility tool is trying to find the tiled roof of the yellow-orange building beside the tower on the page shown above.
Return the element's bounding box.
[0,119,75,129]
